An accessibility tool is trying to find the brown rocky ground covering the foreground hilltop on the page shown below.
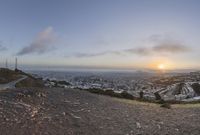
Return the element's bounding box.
[0,88,200,135]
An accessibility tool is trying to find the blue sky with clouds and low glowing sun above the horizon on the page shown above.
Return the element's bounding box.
[0,0,200,70]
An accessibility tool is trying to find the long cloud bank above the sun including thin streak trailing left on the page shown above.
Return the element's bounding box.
[68,35,191,58]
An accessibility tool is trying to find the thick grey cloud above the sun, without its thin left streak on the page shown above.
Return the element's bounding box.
[125,35,191,56]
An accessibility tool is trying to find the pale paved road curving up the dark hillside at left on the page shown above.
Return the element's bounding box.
[0,75,27,90]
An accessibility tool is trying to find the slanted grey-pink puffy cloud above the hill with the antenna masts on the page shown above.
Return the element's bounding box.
[17,27,57,55]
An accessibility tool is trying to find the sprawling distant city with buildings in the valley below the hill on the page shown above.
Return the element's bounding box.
[28,71,200,101]
